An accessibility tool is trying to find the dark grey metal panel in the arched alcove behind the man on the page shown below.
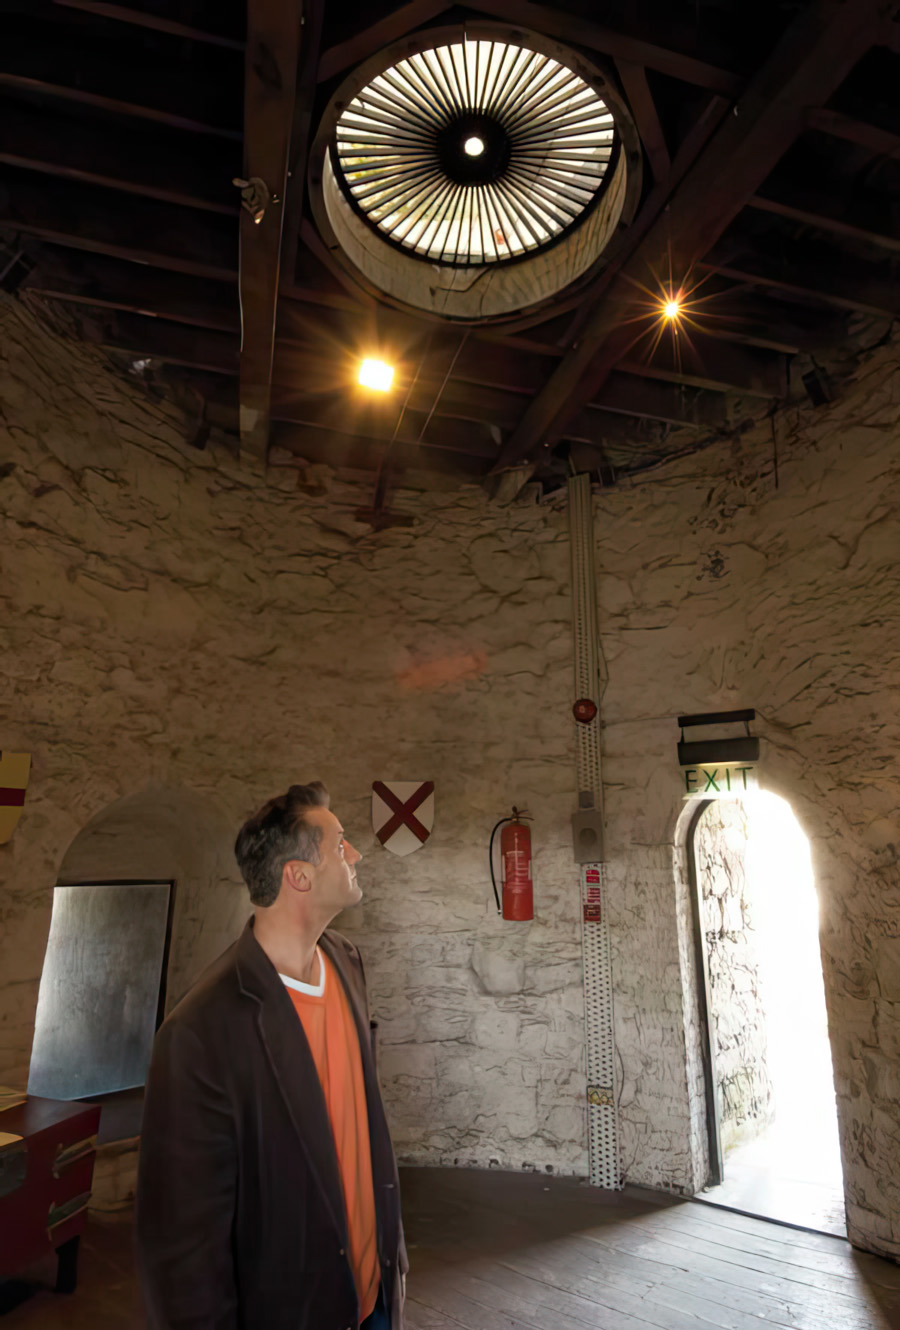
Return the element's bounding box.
[28,882,171,1100]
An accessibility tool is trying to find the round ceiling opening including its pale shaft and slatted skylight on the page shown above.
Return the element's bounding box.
[308,21,642,323]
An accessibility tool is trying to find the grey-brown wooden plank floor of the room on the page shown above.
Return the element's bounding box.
[0,1169,900,1330]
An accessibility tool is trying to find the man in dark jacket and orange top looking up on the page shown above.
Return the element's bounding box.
[137,782,408,1330]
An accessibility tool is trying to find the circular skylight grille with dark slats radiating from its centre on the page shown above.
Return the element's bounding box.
[332,40,616,266]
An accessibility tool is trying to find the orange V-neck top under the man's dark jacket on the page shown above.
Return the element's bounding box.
[282,951,380,1321]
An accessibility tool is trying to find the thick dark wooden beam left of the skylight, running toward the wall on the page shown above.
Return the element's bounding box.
[239,0,303,466]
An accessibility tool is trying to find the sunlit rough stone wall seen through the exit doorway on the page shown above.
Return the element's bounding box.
[694,799,775,1150]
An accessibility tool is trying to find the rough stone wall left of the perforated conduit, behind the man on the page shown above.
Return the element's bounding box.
[0,299,586,1173]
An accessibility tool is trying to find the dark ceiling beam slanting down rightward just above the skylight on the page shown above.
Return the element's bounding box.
[472,0,744,97]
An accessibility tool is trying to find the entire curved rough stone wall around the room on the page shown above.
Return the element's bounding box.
[0,301,900,1256]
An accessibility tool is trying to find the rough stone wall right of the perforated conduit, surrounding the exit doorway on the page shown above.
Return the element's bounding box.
[596,335,900,1256]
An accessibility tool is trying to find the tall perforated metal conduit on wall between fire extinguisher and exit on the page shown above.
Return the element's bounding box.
[569,475,622,1189]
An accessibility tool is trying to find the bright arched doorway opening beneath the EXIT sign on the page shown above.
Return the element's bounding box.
[689,790,845,1234]
